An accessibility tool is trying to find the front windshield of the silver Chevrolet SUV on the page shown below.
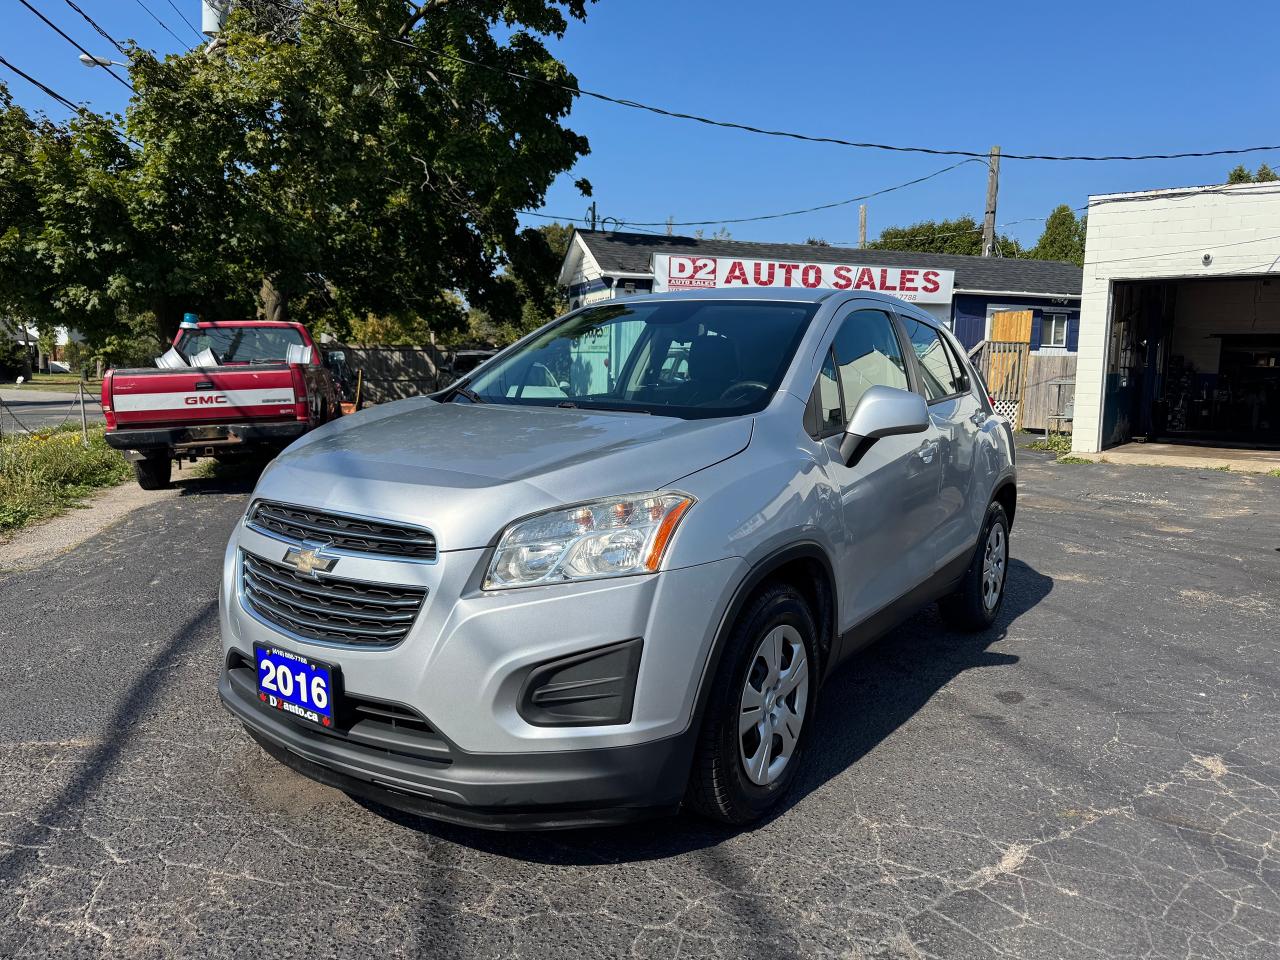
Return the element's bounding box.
[465,300,818,419]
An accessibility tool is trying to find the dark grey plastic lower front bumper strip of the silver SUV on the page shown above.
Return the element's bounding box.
[218,669,696,829]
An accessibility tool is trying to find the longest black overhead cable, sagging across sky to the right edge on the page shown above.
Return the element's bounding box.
[267,0,1280,161]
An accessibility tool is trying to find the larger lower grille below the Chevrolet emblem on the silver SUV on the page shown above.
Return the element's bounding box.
[241,552,426,646]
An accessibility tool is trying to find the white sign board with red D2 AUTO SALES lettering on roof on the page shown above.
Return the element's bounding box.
[653,253,955,303]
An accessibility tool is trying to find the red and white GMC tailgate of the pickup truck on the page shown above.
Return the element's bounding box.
[110,364,297,429]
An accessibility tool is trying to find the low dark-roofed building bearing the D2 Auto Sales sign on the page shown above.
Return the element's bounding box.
[559,230,1083,353]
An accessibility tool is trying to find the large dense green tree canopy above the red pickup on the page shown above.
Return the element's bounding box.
[0,0,590,353]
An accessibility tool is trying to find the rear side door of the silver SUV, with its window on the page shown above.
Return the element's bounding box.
[899,314,987,570]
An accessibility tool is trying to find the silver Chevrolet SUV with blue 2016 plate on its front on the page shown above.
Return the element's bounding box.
[219,291,1015,828]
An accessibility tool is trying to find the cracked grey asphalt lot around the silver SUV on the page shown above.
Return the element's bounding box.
[0,453,1280,960]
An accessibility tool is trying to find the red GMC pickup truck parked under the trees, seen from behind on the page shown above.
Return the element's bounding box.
[102,320,342,490]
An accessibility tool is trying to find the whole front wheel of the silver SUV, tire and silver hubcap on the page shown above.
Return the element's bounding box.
[689,584,818,826]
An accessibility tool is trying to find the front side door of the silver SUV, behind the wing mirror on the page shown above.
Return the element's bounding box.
[813,302,940,630]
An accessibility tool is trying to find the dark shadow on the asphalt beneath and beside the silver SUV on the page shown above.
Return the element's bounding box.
[352,559,1053,869]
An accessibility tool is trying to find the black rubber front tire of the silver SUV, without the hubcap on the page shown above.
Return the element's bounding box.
[687,584,820,826]
